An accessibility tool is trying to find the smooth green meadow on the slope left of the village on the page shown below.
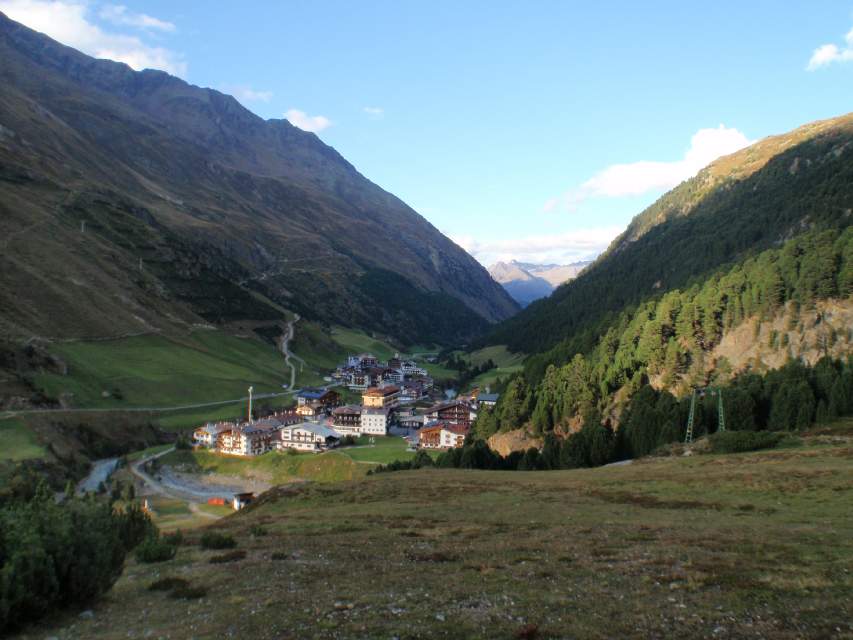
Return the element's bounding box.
[35,331,289,408]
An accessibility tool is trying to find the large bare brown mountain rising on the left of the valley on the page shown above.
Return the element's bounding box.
[0,14,518,342]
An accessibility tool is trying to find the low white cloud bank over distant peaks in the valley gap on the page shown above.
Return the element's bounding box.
[451,226,624,266]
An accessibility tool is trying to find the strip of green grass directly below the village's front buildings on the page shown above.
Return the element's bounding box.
[161,450,370,484]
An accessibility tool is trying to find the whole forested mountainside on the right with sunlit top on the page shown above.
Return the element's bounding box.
[476,114,853,444]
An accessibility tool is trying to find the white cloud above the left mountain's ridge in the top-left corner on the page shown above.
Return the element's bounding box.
[0,0,187,76]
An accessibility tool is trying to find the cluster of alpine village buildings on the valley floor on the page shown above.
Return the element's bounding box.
[193,353,498,457]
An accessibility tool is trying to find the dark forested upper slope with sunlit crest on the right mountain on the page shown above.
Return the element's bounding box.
[488,115,853,353]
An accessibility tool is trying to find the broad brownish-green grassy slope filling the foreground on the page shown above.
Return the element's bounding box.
[38,439,853,640]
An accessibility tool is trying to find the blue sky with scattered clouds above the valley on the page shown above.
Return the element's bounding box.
[5,0,853,266]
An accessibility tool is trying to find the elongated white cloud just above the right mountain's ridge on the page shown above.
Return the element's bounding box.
[543,125,752,212]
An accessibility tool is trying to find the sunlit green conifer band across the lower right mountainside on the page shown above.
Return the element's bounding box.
[475,228,853,438]
